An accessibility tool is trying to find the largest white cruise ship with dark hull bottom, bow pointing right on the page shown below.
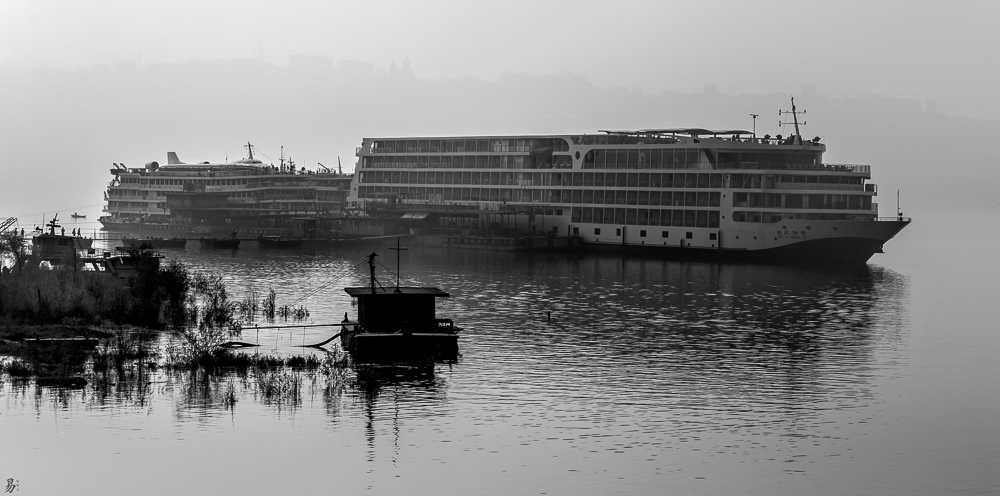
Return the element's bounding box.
[348,108,910,263]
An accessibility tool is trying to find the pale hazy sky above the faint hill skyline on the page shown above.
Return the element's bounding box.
[0,0,1000,119]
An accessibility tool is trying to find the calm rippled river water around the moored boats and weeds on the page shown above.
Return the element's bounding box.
[0,207,1000,495]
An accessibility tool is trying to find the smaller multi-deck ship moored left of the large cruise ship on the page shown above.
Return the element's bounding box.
[100,144,351,235]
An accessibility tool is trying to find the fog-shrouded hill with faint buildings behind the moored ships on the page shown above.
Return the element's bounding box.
[0,57,1000,215]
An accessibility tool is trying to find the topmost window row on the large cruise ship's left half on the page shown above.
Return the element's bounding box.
[368,138,569,153]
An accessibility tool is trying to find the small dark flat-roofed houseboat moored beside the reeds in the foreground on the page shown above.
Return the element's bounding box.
[340,253,461,363]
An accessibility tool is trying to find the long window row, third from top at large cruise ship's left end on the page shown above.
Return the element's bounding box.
[361,170,863,189]
